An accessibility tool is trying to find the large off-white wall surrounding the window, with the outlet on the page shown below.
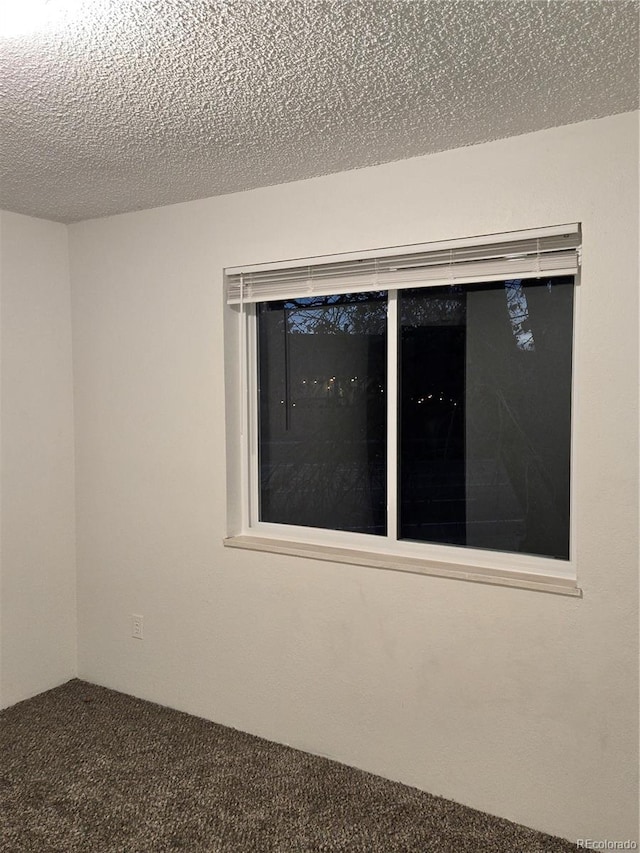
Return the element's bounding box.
[70,115,638,839]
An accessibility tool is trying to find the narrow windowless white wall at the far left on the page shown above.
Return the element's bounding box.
[0,212,76,707]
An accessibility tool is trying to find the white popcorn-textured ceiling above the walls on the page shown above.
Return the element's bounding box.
[0,0,639,222]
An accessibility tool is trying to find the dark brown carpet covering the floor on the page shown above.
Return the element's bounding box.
[0,680,575,853]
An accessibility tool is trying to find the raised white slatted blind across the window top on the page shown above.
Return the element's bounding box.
[225,224,581,304]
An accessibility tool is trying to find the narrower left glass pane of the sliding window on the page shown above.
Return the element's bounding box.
[258,293,387,535]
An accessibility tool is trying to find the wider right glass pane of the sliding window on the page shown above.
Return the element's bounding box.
[399,277,573,559]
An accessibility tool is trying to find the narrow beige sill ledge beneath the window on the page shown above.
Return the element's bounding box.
[223,535,582,598]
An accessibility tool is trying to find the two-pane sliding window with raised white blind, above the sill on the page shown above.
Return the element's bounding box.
[227,226,580,586]
